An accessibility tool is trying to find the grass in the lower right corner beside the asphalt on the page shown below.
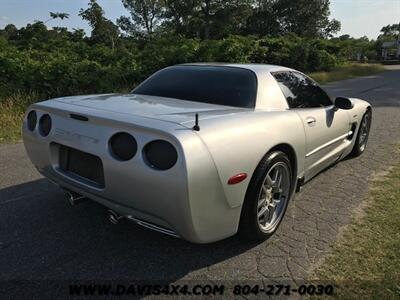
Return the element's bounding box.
[313,149,400,299]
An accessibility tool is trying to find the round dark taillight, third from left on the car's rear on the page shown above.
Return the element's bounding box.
[110,132,137,161]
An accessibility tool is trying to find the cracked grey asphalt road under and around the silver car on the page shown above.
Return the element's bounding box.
[0,70,400,296]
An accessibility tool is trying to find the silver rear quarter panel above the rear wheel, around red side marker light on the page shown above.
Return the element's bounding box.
[198,111,305,207]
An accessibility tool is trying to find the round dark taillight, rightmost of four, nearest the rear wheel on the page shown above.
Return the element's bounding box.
[143,140,178,170]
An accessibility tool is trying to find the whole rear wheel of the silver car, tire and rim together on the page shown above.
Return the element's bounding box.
[239,151,294,240]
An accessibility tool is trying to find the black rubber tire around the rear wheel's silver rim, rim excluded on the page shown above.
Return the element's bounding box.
[238,151,295,241]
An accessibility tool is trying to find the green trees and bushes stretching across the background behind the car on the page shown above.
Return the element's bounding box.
[0,0,399,97]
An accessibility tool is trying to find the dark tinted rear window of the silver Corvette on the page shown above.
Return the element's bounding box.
[133,65,257,108]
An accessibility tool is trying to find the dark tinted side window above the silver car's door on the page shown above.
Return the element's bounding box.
[272,72,332,108]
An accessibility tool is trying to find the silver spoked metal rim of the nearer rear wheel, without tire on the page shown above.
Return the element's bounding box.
[257,162,290,233]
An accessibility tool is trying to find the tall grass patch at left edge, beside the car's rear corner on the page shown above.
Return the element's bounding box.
[0,93,38,143]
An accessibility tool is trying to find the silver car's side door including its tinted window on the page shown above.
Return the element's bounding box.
[273,72,351,180]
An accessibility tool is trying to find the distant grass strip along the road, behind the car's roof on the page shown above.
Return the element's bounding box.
[308,64,385,84]
